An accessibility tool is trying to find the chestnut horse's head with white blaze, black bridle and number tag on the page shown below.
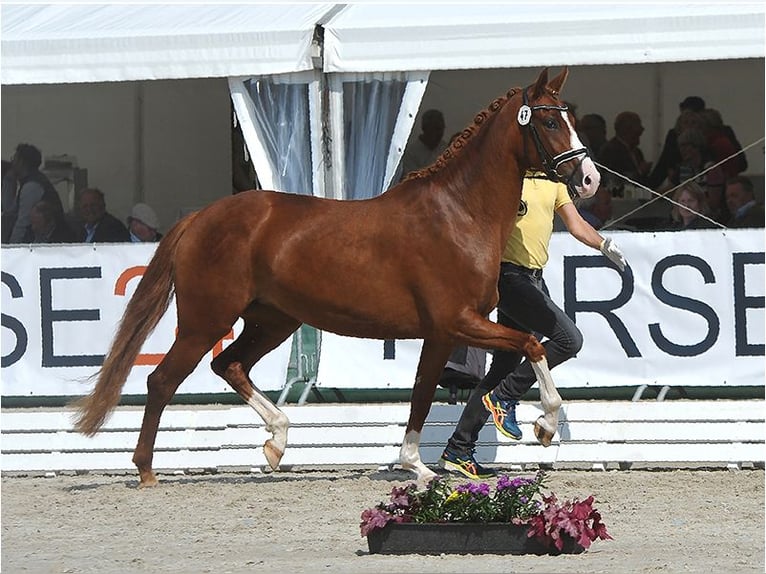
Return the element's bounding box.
[516,67,601,198]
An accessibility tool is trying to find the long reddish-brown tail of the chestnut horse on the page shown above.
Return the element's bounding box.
[74,214,196,436]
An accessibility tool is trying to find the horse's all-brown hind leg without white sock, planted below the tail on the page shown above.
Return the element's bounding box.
[133,330,226,488]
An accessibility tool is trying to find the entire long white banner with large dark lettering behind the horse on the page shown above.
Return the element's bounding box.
[2,229,765,397]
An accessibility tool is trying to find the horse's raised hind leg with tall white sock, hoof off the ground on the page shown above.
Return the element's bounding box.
[211,305,300,470]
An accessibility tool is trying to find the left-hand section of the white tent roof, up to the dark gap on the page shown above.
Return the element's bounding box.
[0,4,334,84]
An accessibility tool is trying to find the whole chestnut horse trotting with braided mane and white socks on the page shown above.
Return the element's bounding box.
[76,68,600,487]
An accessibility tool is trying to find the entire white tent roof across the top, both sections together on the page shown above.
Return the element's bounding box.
[0,0,766,84]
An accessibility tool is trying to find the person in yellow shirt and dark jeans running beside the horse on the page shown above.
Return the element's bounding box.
[440,172,625,479]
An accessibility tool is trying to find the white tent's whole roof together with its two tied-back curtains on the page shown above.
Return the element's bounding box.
[0,2,765,218]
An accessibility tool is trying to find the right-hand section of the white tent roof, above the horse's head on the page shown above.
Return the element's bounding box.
[324,2,766,72]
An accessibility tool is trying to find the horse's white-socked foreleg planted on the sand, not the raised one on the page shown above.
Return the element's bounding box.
[399,340,452,482]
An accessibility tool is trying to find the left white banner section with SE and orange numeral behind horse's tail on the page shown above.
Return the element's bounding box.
[2,243,292,397]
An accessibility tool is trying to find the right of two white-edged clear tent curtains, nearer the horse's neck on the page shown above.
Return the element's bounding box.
[329,72,428,199]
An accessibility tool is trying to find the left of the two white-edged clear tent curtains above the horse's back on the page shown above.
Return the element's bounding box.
[229,72,314,195]
